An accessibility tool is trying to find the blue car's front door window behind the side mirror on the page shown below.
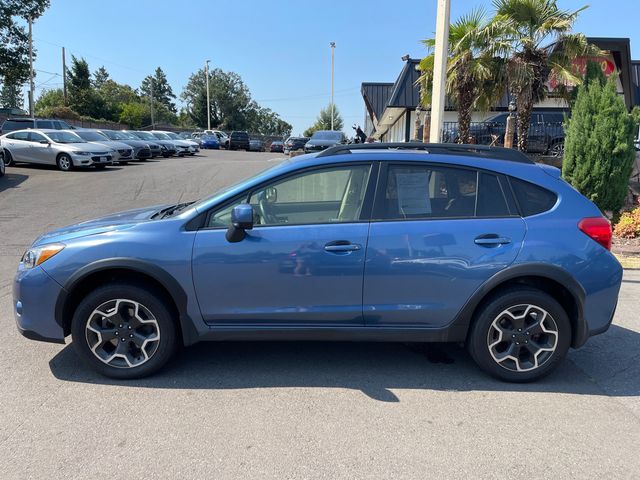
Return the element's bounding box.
[208,165,371,227]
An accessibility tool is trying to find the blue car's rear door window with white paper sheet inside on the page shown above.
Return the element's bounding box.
[379,165,477,220]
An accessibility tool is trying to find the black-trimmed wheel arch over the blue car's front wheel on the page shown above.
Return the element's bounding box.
[55,258,198,345]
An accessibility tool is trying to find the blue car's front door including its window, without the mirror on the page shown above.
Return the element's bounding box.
[193,164,371,326]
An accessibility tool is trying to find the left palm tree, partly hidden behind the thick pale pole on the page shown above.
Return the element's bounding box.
[418,8,504,143]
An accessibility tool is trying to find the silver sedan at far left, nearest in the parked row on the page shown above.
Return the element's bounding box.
[0,129,114,171]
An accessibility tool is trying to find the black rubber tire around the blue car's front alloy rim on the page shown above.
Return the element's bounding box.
[71,283,178,379]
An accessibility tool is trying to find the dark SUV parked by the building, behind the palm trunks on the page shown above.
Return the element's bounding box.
[444,112,564,157]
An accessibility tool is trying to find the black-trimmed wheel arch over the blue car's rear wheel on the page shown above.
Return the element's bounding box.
[458,264,589,348]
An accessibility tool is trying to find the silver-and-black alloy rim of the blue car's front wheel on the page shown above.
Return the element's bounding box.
[85,298,160,368]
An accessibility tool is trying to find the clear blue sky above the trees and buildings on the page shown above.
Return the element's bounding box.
[25,0,640,134]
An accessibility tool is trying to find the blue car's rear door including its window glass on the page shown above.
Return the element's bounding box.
[363,162,525,327]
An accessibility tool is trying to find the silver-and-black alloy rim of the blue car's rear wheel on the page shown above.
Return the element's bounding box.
[487,304,558,372]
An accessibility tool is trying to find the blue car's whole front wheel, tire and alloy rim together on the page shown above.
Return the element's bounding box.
[71,284,177,379]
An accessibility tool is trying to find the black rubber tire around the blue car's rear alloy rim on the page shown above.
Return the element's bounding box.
[467,287,571,382]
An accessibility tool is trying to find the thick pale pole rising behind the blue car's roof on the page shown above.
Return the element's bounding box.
[429,0,451,143]
